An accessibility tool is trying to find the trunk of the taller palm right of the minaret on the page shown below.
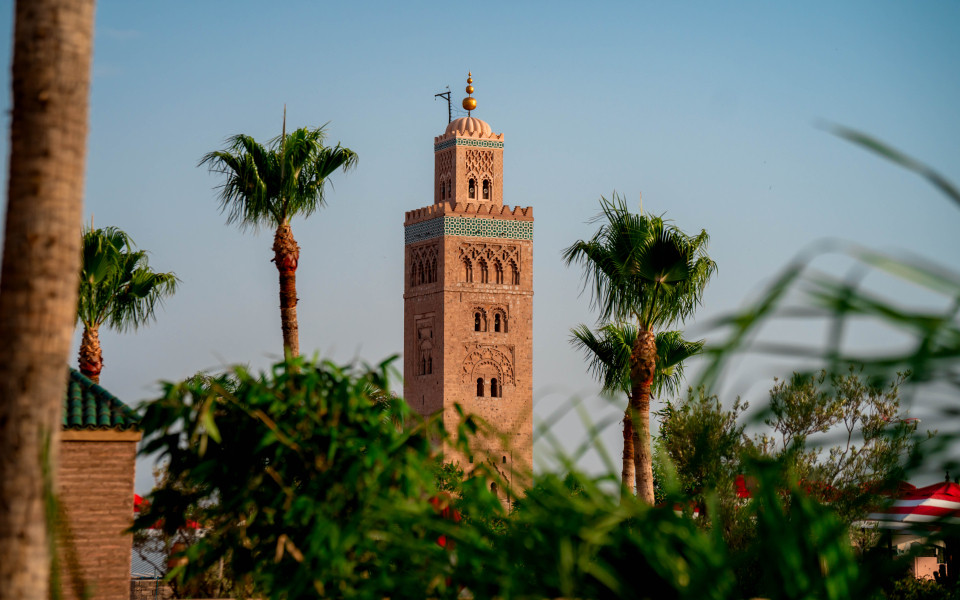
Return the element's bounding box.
[630,331,657,504]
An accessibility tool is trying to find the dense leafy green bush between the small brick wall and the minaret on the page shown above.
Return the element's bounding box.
[136,361,460,598]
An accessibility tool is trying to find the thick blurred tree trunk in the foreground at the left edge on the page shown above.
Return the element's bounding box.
[0,0,94,600]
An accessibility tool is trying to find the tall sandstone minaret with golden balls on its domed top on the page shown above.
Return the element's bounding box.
[403,74,533,486]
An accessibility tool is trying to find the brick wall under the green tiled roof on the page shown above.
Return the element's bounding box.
[58,431,139,600]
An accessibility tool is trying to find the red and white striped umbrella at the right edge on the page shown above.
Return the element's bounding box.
[867,481,960,529]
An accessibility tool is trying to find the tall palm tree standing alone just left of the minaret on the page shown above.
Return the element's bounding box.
[200,116,357,356]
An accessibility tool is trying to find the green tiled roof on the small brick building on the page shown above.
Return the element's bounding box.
[63,368,140,429]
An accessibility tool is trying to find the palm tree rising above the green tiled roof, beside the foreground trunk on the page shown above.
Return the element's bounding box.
[77,227,179,383]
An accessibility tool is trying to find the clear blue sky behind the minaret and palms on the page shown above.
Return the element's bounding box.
[0,0,960,491]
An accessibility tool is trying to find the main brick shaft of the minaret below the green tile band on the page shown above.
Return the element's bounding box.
[404,227,533,486]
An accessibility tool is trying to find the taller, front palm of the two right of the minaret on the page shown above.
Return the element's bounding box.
[563,194,716,503]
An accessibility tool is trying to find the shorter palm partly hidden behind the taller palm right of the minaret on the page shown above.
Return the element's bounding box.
[570,323,704,494]
